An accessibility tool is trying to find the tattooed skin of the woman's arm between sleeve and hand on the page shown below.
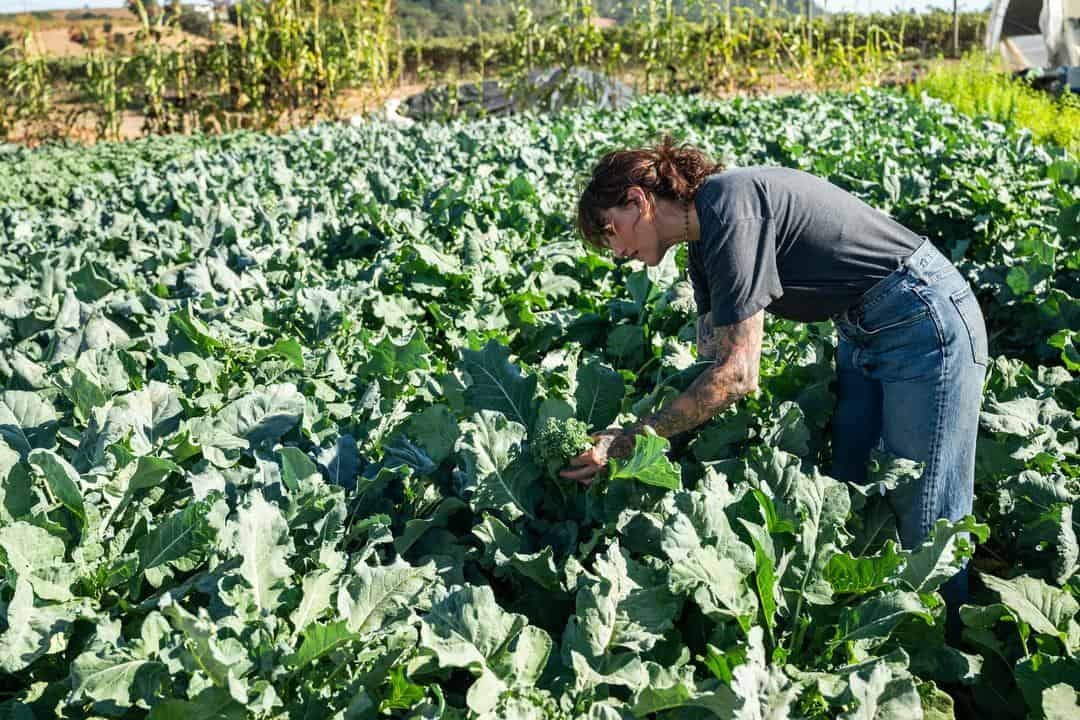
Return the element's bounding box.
[622,311,765,457]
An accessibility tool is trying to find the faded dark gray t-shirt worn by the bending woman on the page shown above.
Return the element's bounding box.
[688,167,923,326]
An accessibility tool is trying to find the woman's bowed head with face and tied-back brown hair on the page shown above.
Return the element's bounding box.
[578,136,724,264]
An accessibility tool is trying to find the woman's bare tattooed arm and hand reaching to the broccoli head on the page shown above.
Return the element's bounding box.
[561,310,765,480]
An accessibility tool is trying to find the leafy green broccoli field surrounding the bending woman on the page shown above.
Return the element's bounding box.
[0,91,1080,720]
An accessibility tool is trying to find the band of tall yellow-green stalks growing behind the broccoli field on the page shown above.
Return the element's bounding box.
[0,0,986,142]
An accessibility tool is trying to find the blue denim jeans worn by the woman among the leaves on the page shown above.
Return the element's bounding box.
[833,241,987,613]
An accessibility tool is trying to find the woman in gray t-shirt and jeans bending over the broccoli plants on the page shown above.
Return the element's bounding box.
[563,138,987,612]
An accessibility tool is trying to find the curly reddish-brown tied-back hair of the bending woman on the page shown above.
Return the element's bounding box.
[577,135,724,247]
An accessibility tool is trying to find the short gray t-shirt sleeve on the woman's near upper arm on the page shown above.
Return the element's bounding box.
[691,216,784,327]
